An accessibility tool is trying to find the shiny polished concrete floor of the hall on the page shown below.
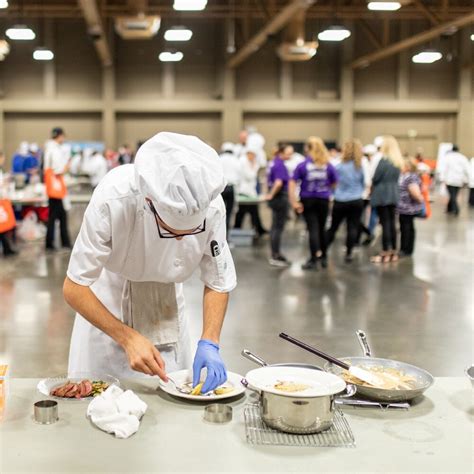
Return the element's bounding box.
[0,189,474,377]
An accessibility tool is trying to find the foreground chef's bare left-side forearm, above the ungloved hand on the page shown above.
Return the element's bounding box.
[63,277,130,346]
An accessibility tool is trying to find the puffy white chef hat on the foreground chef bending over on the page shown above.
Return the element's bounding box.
[135,132,226,230]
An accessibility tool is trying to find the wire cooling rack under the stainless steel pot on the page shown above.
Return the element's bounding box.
[244,403,355,448]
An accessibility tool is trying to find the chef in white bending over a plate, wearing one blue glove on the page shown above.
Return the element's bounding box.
[64,132,236,393]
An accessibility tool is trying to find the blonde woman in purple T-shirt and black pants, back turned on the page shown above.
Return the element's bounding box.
[289,137,337,270]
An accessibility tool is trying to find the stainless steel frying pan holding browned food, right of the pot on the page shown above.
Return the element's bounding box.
[324,330,434,402]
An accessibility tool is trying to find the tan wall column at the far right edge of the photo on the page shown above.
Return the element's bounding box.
[456,28,474,156]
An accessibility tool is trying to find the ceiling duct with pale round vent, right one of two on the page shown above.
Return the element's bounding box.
[277,10,318,61]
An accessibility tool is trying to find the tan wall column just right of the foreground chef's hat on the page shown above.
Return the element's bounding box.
[221,68,243,142]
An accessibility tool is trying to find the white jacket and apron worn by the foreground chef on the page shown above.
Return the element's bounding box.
[67,164,236,377]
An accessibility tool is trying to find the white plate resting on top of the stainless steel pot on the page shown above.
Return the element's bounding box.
[245,367,346,398]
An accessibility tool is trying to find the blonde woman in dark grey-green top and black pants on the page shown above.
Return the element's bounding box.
[370,135,403,263]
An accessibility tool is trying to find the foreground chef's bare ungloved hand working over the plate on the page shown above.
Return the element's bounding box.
[123,329,168,382]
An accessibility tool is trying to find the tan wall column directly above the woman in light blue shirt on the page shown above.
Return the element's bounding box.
[339,25,354,146]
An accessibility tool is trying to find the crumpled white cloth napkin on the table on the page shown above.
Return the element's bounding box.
[87,385,148,438]
